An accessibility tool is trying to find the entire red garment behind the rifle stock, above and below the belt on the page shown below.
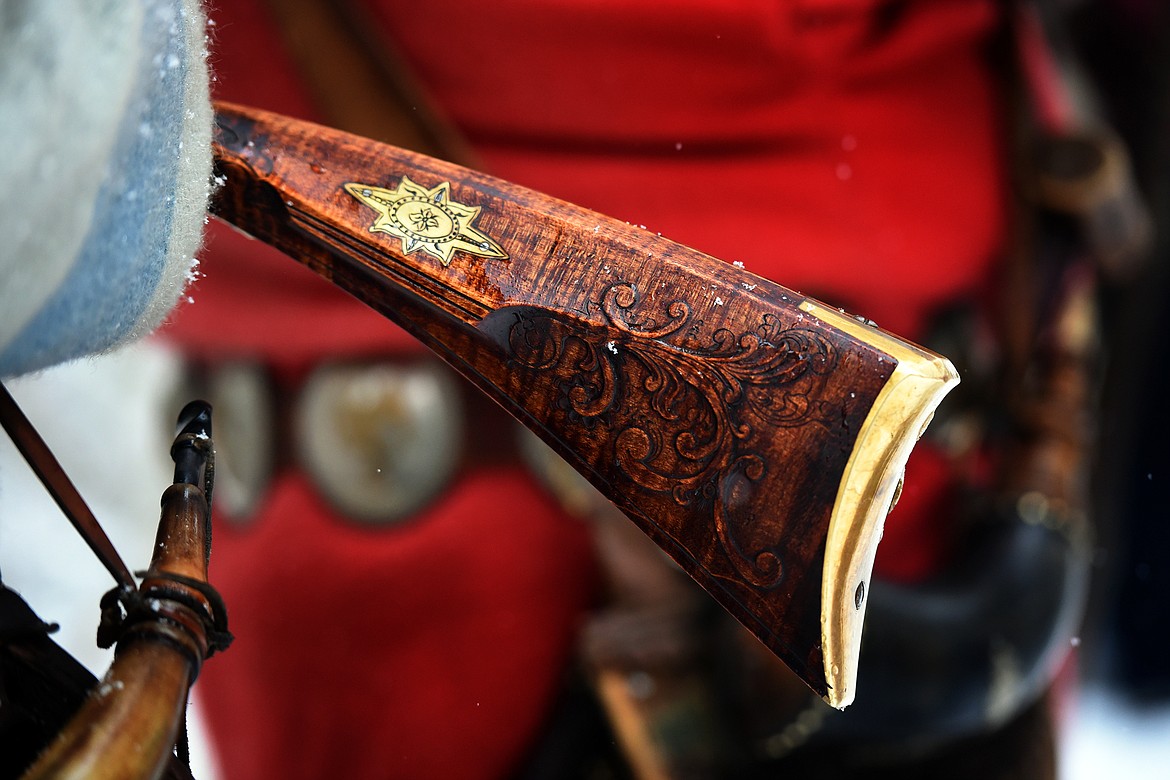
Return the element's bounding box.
[171,0,1004,778]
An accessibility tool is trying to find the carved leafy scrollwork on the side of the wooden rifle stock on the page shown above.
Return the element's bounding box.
[507,283,837,587]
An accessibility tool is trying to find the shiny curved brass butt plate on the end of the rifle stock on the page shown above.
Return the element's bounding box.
[800,301,958,709]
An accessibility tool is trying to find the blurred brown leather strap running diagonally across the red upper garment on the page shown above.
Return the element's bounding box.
[267,0,480,168]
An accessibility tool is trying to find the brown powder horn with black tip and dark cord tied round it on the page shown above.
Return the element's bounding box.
[23,402,221,780]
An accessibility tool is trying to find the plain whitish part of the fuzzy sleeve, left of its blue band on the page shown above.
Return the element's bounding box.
[0,0,144,350]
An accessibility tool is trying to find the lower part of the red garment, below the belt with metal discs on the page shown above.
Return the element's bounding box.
[197,469,593,780]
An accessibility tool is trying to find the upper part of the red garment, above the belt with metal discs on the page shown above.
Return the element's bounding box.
[178,0,1004,356]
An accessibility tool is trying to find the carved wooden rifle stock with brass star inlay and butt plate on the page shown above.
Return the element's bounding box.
[214,104,958,706]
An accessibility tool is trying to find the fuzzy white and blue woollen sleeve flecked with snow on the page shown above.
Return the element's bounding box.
[0,0,212,377]
